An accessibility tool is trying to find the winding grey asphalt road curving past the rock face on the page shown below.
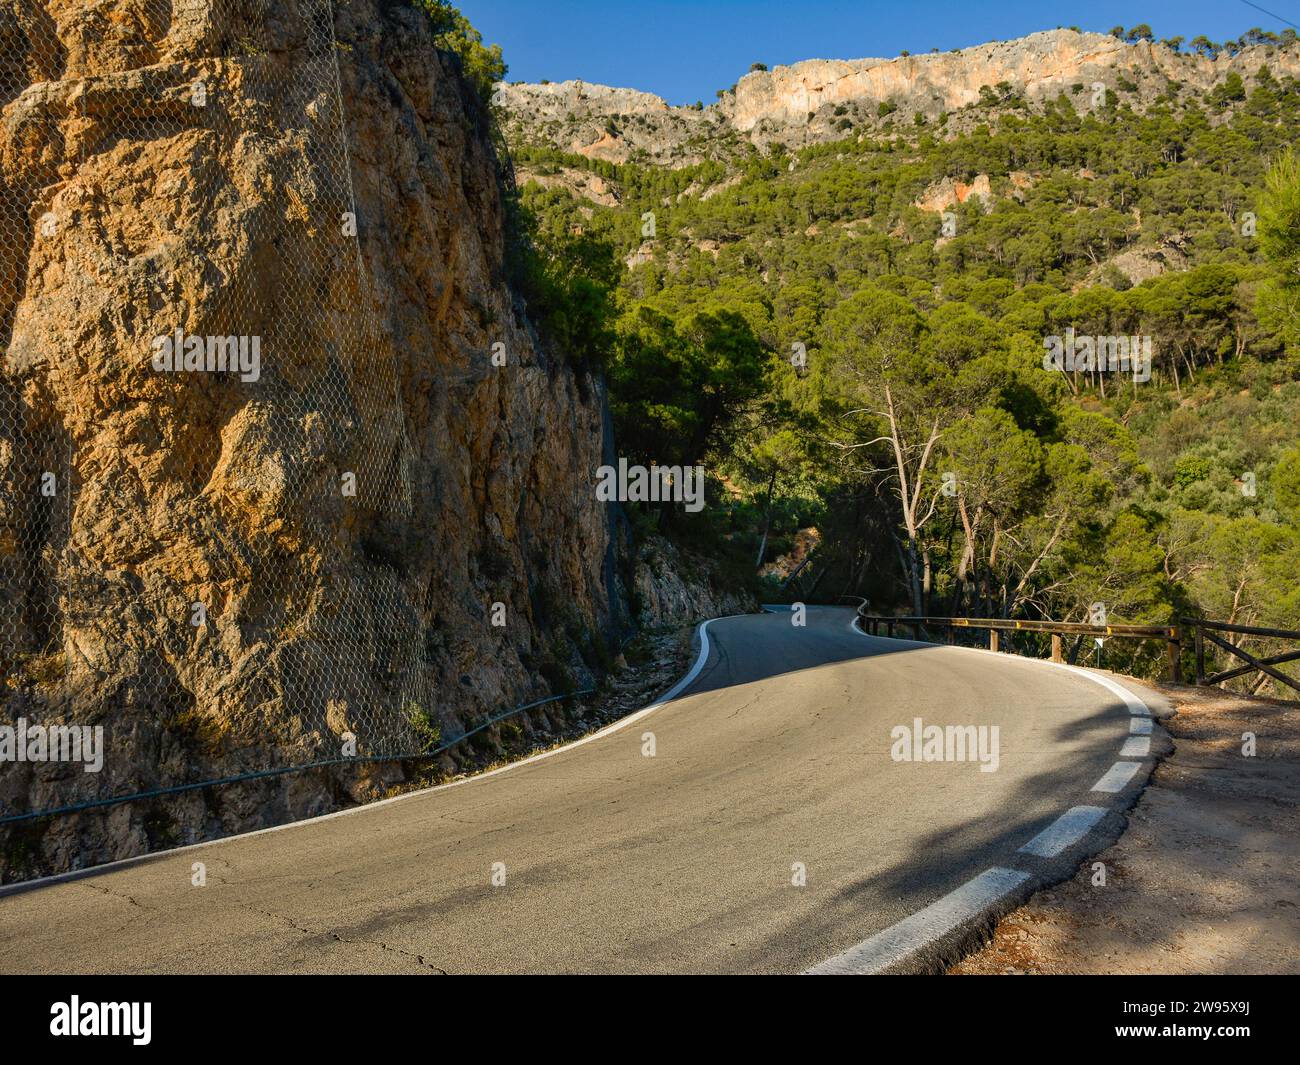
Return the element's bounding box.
[0,607,1160,973]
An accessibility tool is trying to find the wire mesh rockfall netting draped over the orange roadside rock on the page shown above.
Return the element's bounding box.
[0,0,437,815]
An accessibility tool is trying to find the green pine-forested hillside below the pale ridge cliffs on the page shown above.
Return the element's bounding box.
[491,22,1300,681]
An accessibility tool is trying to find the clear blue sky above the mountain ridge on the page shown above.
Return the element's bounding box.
[460,0,1300,104]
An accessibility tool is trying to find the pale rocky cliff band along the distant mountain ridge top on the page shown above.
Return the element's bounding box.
[495,30,1300,165]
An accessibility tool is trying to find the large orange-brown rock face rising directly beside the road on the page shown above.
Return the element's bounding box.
[0,0,620,879]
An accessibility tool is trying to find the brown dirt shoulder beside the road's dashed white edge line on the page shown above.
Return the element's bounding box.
[949,685,1300,975]
